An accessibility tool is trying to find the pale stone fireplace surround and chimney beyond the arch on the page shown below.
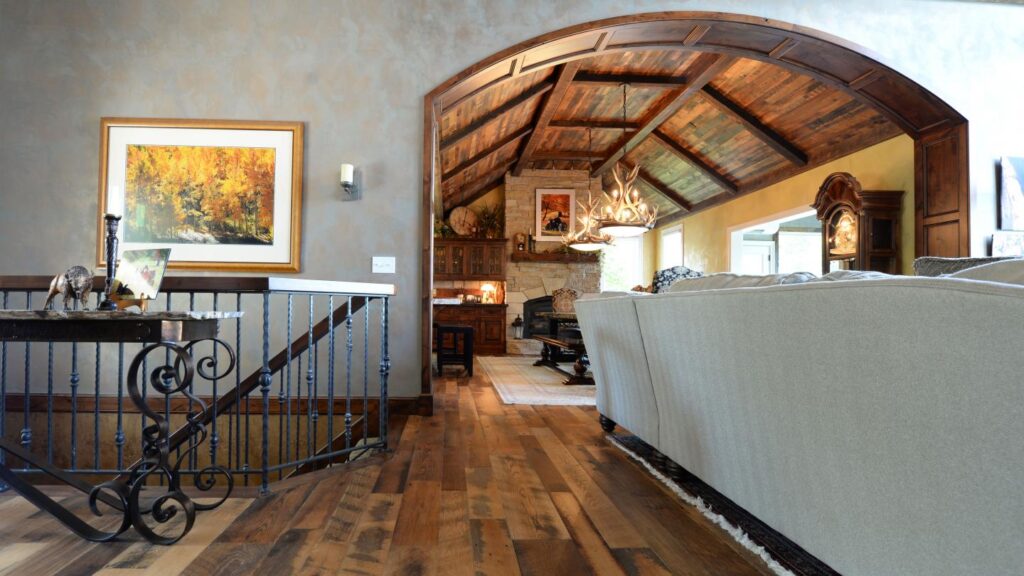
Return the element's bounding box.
[505,170,601,355]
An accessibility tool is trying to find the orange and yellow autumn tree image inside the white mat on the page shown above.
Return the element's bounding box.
[124,145,275,245]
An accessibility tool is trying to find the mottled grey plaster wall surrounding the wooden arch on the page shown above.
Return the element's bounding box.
[0,0,1024,396]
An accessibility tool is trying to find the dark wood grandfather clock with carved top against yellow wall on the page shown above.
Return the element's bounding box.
[813,172,903,274]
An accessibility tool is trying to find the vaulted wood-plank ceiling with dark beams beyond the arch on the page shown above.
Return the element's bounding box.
[437,46,904,222]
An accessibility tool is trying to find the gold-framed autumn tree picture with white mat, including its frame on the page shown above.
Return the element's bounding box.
[96,118,302,272]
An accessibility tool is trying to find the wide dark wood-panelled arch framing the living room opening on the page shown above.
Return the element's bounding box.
[421,12,970,399]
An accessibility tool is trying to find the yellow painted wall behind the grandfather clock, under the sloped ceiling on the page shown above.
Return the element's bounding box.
[682,135,913,275]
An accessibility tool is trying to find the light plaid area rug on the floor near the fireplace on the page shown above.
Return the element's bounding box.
[477,356,594,406]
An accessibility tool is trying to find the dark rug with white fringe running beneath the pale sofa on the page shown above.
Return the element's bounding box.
[608,435,840,576]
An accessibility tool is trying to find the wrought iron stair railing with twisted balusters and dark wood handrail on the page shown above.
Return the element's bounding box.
[0,276,393,491]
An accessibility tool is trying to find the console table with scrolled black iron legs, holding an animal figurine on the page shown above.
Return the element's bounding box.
[0,311,242,544]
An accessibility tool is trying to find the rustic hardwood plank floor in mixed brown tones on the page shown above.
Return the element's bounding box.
[0,360,770,576]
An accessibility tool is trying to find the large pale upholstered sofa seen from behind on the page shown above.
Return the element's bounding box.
[577,277,1024,576]
